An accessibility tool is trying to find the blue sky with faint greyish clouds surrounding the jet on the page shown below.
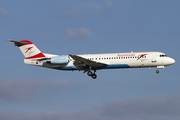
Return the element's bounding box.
[0,0,180,120]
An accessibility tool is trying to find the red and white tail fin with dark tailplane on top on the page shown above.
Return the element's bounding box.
[7,40,46,59]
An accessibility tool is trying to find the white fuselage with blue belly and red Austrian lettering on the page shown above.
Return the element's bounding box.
[24,52,175,70]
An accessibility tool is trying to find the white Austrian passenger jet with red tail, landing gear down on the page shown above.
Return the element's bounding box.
[7,40,175,79]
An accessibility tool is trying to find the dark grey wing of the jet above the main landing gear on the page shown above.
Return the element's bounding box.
[69,55,107,67]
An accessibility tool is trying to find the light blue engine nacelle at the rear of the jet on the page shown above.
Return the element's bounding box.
[46,56,69,65]
